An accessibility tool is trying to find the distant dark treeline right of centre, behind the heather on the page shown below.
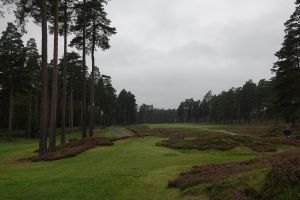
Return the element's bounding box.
[178,80,278,123]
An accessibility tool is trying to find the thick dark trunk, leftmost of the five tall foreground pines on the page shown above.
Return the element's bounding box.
[39,0,48,156]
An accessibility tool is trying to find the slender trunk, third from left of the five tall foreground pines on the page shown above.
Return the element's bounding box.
[60,0,68,144]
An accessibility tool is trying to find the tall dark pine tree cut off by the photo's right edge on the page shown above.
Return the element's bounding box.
[273,0,300,124]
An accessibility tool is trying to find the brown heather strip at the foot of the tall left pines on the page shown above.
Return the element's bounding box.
[31,138,113,162]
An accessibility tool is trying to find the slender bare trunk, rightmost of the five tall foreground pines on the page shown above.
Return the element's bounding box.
[89,22,96,137]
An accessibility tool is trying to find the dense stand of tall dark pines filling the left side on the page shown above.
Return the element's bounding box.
[0,0,137,155]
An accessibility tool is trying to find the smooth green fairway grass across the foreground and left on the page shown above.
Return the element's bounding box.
[0,133,272,200]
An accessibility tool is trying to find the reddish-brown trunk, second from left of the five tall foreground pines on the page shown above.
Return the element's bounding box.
[49,0,59,153]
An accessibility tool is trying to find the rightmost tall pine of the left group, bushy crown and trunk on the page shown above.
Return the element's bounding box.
[71,0,116,137]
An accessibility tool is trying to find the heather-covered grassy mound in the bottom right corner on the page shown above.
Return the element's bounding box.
[168,151,300,200]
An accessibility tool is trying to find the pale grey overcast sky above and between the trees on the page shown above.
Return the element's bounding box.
[0,0,295,108]
